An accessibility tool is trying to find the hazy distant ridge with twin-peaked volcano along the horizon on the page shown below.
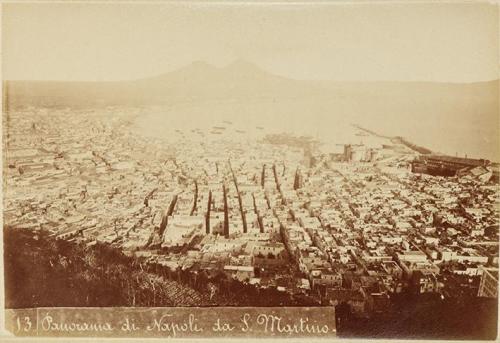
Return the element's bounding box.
[4,60,498,107]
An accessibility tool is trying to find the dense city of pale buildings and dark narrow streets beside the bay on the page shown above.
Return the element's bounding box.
[3,107,500,316]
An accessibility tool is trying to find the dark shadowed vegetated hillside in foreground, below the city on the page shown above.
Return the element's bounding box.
[4,228,314,308]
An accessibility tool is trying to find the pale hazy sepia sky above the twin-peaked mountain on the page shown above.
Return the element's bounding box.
[2,2,499,82]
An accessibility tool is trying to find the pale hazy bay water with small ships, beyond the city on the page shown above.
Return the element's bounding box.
[135,100,500,161]
